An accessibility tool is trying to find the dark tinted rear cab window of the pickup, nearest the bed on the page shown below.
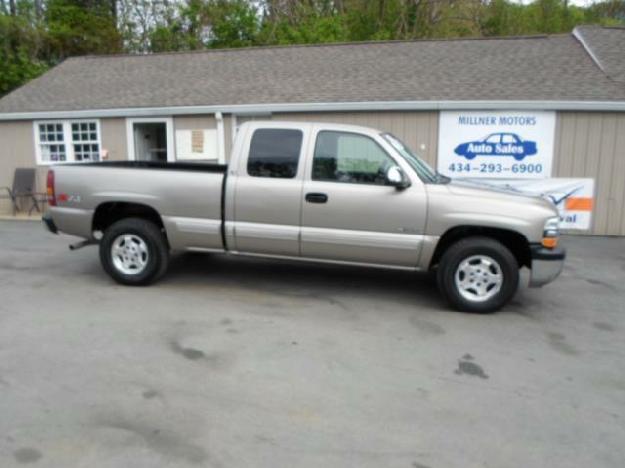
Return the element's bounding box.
[247,128,303,179]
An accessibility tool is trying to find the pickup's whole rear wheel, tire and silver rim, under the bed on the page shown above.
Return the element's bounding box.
[100,218,169,286]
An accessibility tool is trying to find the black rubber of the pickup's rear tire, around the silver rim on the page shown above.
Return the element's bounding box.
[100,218,169,286]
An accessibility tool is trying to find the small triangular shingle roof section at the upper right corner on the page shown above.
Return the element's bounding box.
[575,26,625,83]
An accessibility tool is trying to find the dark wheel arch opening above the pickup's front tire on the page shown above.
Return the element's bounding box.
[429,225,532,270]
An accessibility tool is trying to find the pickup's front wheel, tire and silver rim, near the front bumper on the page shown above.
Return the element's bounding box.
[436,237,519,313]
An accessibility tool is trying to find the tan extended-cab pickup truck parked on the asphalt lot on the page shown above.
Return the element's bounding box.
[44,121,565,312]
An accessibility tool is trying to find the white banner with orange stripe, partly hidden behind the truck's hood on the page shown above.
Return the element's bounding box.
[479,178,595,230]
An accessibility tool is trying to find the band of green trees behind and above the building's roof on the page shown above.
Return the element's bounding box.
[0,0,625,95]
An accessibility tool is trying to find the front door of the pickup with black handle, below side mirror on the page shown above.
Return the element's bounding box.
[301,126,427,267]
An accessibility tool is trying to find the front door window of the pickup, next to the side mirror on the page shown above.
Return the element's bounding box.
[312,131,395,185]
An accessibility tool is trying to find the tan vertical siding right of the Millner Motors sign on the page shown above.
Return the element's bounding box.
[553,112,625,236]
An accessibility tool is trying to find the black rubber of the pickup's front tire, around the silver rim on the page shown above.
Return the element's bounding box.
[436,237,519,313]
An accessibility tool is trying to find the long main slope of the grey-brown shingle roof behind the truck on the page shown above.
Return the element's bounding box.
[0,29,625,113]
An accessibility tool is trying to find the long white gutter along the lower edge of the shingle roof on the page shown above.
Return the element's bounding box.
[0,101,625,121]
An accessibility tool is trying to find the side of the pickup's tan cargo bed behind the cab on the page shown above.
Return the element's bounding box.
[50,161,227,250]
